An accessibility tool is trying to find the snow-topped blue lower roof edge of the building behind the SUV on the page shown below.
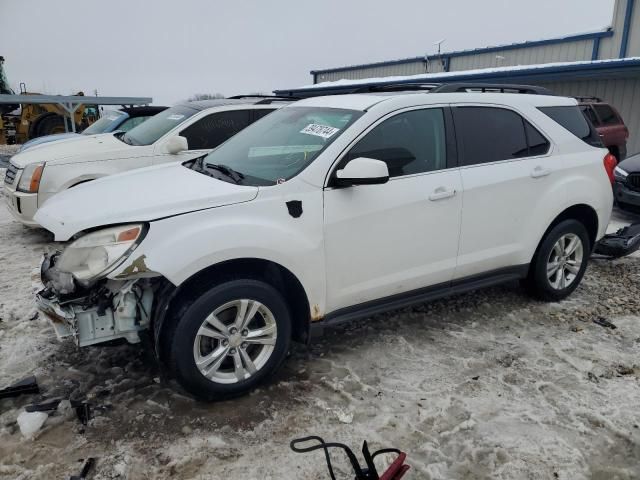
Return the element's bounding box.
[274,58,640,95]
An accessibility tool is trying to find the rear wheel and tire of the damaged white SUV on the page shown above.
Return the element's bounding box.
[525,220,591,302]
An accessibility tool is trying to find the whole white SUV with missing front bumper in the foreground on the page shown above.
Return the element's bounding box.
[36,87,613,399]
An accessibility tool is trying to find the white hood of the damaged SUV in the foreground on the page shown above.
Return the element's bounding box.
[34,163,258,241]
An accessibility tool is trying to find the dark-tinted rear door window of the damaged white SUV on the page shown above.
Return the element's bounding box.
[453,107,549,165]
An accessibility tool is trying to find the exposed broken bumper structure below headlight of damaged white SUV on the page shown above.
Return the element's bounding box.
[36,254,154,347]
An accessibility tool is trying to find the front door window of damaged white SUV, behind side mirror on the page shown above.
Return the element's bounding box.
[341,108,447,177]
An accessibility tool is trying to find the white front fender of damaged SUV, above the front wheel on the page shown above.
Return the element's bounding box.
[109,191,325,315]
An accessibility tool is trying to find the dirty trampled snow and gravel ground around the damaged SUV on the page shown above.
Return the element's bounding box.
[0,173,640,480]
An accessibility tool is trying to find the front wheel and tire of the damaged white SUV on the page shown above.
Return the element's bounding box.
[162,279,291,401]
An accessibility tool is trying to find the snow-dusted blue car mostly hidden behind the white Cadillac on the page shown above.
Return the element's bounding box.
[18,106,167,152]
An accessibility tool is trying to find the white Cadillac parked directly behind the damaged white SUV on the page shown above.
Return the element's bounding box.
[4,97,287,226]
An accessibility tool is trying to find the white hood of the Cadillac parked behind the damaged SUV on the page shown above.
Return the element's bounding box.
[11,133,131,168]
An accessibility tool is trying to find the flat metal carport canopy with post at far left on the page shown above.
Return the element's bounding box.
[0,94,153,132]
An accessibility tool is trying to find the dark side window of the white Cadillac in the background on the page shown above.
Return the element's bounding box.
[180,110,251,150]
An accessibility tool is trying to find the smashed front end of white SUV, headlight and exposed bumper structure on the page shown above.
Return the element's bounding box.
[36,225,162,347]
